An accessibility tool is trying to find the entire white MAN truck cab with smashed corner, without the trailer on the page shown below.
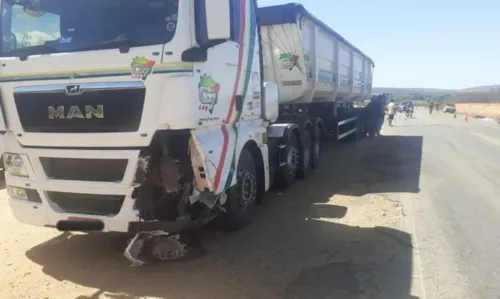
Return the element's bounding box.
[0,0,277,239]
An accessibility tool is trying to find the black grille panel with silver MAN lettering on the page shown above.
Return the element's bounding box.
[14,82,146,133]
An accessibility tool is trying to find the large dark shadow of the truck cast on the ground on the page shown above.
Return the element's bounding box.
[26,136,421,299]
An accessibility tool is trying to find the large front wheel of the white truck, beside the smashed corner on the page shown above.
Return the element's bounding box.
[220,148,258,230]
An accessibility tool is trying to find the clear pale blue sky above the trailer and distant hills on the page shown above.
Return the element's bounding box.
[258,0,500,89]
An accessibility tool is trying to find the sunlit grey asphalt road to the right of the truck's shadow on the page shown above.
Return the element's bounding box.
[387,109,500,299]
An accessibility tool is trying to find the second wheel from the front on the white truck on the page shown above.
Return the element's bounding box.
[276,132,300,188]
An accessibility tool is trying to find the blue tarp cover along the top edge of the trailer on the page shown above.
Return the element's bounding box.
[257,3,375,67]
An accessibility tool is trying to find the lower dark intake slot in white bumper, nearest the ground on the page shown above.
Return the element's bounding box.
[47,191,125,216]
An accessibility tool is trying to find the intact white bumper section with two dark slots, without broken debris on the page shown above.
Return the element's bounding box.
[2,132,139,233]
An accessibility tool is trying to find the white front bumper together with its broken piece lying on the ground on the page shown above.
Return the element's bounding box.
[4,134,214,265]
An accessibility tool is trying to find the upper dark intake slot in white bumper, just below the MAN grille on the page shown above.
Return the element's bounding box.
[40,157,128,182]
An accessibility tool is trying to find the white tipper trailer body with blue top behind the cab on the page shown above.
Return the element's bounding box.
[258,4,374,104]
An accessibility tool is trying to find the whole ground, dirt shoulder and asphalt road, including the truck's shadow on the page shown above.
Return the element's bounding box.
[0,109,500,299]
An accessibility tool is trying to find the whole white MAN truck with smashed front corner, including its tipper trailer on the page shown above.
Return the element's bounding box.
[0,0,374,264]
